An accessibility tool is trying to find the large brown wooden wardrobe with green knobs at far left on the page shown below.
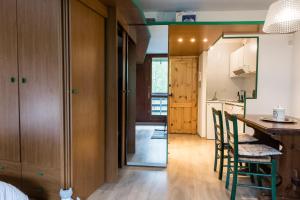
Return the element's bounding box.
[0,0,106,200]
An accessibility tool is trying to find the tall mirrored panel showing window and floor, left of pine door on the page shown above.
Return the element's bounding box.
[127,26,169,167]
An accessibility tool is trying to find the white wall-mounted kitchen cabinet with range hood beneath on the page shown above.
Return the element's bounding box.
[230,40,257,78]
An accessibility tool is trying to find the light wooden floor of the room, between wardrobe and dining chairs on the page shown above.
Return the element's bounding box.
[89,135,256,200]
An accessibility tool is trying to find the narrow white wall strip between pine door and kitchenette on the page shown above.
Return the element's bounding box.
[198,51,207,137]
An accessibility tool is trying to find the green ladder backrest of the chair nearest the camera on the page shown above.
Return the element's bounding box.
[224,112,239,159]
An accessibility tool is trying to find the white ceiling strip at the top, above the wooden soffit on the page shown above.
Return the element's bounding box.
[140,0,275,11]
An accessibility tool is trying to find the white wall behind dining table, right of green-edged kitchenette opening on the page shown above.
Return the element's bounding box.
[246,35,293,114]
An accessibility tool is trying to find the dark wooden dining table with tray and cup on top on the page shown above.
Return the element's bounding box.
[237,115,300,200]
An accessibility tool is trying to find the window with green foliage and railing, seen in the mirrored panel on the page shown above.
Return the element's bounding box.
[151,57,168,116]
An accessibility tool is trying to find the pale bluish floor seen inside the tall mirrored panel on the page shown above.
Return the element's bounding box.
[127,125,167,166]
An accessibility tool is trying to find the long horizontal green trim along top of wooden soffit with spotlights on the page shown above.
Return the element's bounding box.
[146,20,265,26]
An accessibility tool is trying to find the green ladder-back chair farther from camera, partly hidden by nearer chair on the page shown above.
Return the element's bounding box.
[212,108,258,180]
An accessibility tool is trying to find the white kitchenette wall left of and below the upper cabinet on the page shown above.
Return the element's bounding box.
[207,42,244,100]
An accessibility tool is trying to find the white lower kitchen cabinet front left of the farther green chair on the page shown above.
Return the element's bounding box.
[206,103,223,140]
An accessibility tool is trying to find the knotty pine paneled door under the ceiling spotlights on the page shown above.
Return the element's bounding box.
[168,57,198,134]
